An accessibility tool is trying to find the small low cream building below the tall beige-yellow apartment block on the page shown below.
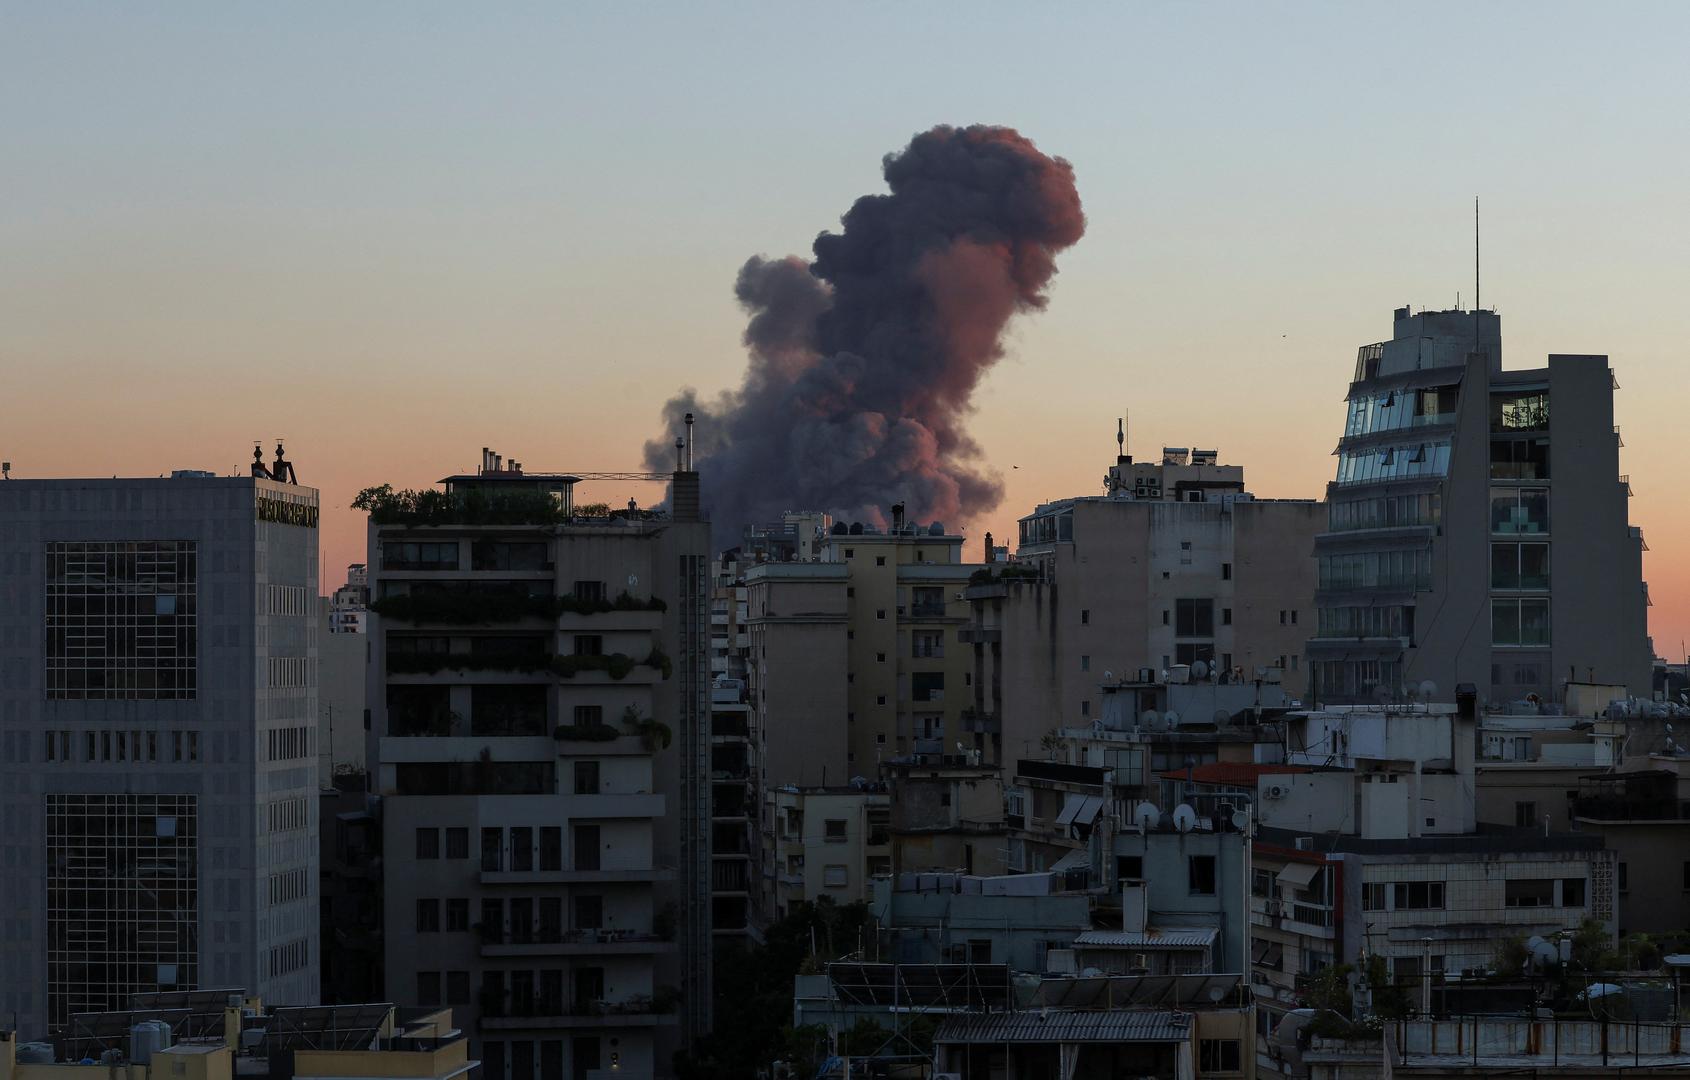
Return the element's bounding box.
[764,784,892,918]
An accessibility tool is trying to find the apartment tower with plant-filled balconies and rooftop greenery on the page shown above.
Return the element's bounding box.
[370,451,713,1080]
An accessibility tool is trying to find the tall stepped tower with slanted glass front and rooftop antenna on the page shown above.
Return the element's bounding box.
[1306,308,1653,703]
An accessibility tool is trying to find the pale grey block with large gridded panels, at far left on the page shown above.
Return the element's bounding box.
[0,453,318,1034]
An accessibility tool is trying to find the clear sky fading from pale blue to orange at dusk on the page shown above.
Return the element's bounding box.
[0,0,1690,657]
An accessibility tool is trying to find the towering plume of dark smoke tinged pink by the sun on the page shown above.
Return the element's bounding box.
[646,125,1085,543]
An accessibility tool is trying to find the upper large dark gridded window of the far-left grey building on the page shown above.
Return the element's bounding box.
[44,541,199,700]
